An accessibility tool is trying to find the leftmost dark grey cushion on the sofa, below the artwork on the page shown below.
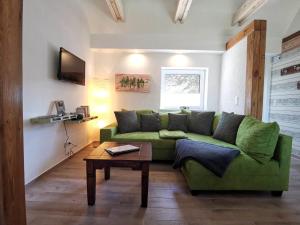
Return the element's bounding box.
[115,111,140,133]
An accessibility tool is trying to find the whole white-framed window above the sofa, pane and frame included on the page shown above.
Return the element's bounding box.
[160,67,208,110]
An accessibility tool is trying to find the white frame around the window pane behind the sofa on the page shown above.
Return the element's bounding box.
[160,67,208,110]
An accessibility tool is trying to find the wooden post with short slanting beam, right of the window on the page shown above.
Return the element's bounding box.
[226,20,267,120]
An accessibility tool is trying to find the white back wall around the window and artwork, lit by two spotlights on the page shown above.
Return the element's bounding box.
[94,52,222,125]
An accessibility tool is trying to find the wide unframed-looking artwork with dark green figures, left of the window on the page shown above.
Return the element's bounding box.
[115,73,150,93]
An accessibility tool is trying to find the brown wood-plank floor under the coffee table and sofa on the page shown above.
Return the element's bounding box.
[26,143,300,225]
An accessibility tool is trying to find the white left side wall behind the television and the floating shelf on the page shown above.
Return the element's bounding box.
[23,0,98,183]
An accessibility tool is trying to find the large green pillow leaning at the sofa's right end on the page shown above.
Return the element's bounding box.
[236,116,279,164]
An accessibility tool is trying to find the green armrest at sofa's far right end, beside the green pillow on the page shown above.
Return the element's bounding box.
[274,134,293,170]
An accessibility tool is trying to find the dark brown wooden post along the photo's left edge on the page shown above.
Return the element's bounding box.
[0,0,26,225]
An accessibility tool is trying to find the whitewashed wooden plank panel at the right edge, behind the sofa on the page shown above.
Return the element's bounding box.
[269,47,300,157]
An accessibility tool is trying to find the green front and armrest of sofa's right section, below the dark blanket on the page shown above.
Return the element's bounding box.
[182,135,292,191]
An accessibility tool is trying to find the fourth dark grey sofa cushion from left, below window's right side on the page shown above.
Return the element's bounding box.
[188,111,215,135]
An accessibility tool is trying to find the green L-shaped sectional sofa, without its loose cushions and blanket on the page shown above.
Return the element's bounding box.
[100,117,292,195]
